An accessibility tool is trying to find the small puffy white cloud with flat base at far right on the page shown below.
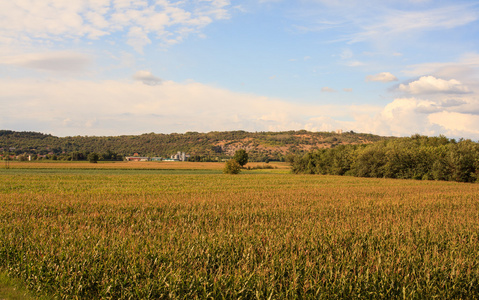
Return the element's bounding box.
[399,76,470,94]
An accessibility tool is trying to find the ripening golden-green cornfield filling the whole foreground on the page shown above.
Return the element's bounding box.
[0,163,479,299]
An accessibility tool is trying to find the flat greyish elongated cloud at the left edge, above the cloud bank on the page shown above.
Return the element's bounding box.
[0,51,92,72]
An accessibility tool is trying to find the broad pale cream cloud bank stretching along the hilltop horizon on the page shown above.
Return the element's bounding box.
[0,77,479,139]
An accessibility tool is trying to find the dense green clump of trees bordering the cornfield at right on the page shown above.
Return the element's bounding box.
[291,135,479,182]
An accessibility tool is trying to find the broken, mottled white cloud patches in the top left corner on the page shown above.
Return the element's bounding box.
[0,0,230,53]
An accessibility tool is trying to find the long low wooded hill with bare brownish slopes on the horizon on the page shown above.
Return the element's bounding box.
[0,130,388,161]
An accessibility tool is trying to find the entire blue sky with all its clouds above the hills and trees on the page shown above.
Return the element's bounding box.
[0,0,479,141]
